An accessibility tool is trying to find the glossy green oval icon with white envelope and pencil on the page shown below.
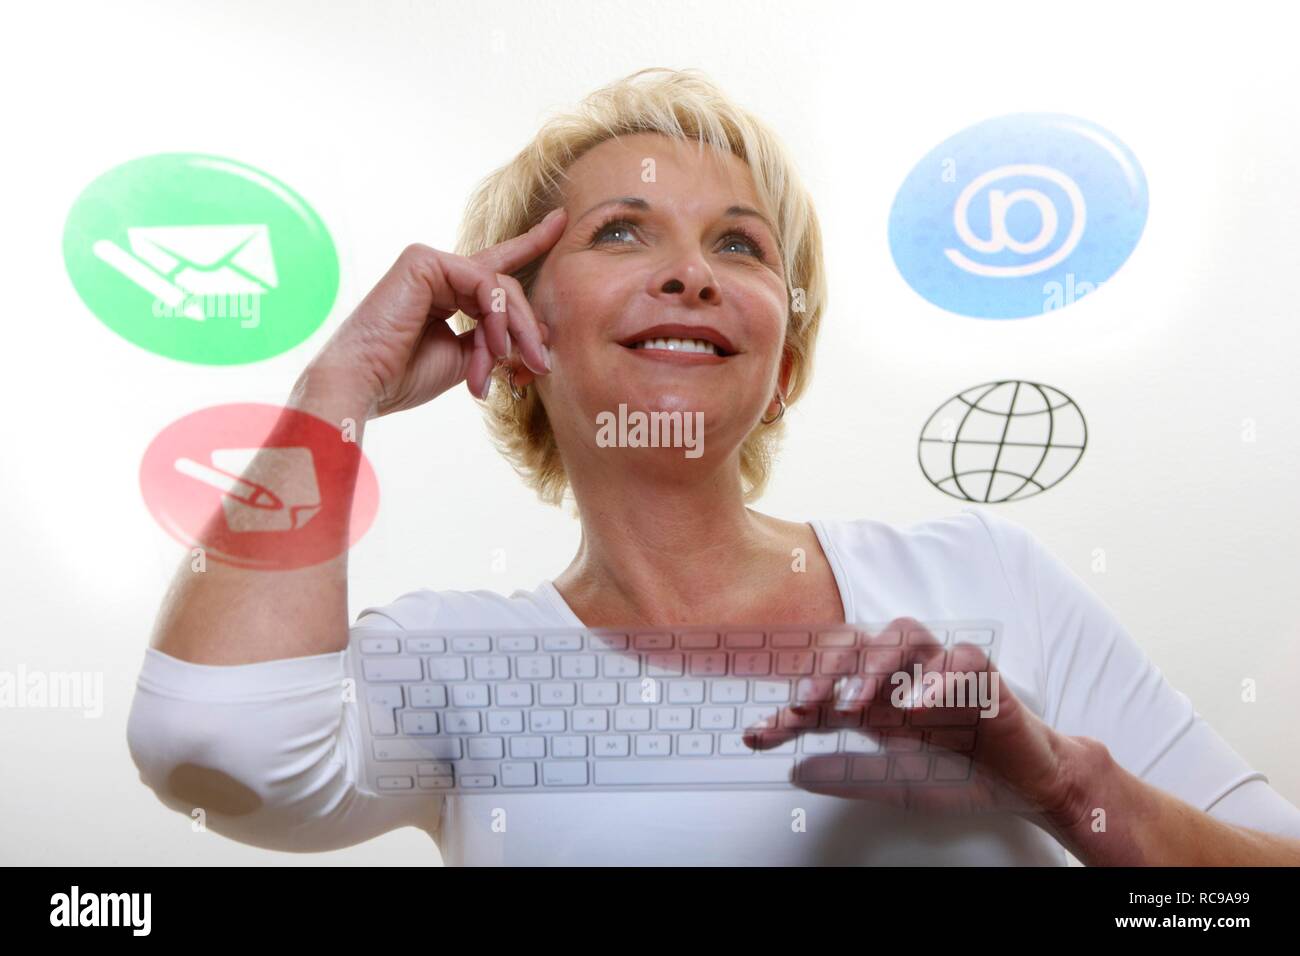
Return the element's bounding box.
[64,153,338,365]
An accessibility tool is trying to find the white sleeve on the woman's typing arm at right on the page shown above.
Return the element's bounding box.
[972,509,1300,835]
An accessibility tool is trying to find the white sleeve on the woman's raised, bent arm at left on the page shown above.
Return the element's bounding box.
[127,615,442,852]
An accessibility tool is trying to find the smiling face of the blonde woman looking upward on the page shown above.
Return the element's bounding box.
[530,133,788,470]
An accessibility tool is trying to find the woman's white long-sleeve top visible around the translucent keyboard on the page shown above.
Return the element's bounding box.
[127,507,1300,865]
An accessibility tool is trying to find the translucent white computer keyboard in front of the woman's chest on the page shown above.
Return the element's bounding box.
[348,620,1001,795]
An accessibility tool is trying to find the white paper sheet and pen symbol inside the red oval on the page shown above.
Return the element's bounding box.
[174,447,321,532]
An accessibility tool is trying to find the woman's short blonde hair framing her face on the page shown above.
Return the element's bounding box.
[454,68,827,506]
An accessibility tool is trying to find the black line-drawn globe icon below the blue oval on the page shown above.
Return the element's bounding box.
[917,381,1088,505]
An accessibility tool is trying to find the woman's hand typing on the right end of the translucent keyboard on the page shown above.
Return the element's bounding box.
[745,618,1092,831]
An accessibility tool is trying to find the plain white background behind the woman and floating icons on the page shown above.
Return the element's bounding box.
[0,0,1300,864]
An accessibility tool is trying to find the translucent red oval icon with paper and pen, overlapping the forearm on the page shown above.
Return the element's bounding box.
[140,403,380,571]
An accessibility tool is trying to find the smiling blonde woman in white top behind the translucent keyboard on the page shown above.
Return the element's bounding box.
[129,70,1300,864]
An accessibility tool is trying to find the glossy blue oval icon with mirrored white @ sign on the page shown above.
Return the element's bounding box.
[889,113,1147,319]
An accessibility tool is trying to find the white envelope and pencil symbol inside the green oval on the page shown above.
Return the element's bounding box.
[91,225,280,321]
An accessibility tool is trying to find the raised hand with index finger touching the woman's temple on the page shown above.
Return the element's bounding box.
[308,207,567,418]
